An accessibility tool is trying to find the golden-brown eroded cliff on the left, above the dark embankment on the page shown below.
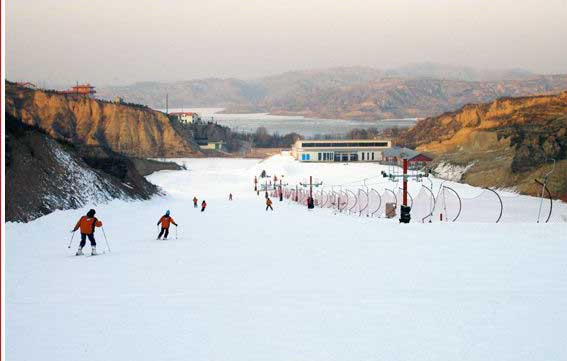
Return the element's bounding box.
[6,82,200,157]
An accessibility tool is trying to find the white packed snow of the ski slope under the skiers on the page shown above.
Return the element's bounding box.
[5,156,567,361]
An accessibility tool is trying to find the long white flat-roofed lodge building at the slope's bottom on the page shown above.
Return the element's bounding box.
[291,139,392,162]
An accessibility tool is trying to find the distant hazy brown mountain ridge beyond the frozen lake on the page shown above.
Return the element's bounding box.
[95,63,567,120]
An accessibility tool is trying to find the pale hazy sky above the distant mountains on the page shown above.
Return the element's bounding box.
[6,0,567,86]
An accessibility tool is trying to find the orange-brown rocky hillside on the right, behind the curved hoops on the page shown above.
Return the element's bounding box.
[398,92,567,198]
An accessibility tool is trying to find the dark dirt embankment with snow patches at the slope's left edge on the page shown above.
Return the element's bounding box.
[5,114,159,222]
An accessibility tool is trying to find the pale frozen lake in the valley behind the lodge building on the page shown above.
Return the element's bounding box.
[164,108,416,137]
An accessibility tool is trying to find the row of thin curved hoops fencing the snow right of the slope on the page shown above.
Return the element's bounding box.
[280,181,563,223]
